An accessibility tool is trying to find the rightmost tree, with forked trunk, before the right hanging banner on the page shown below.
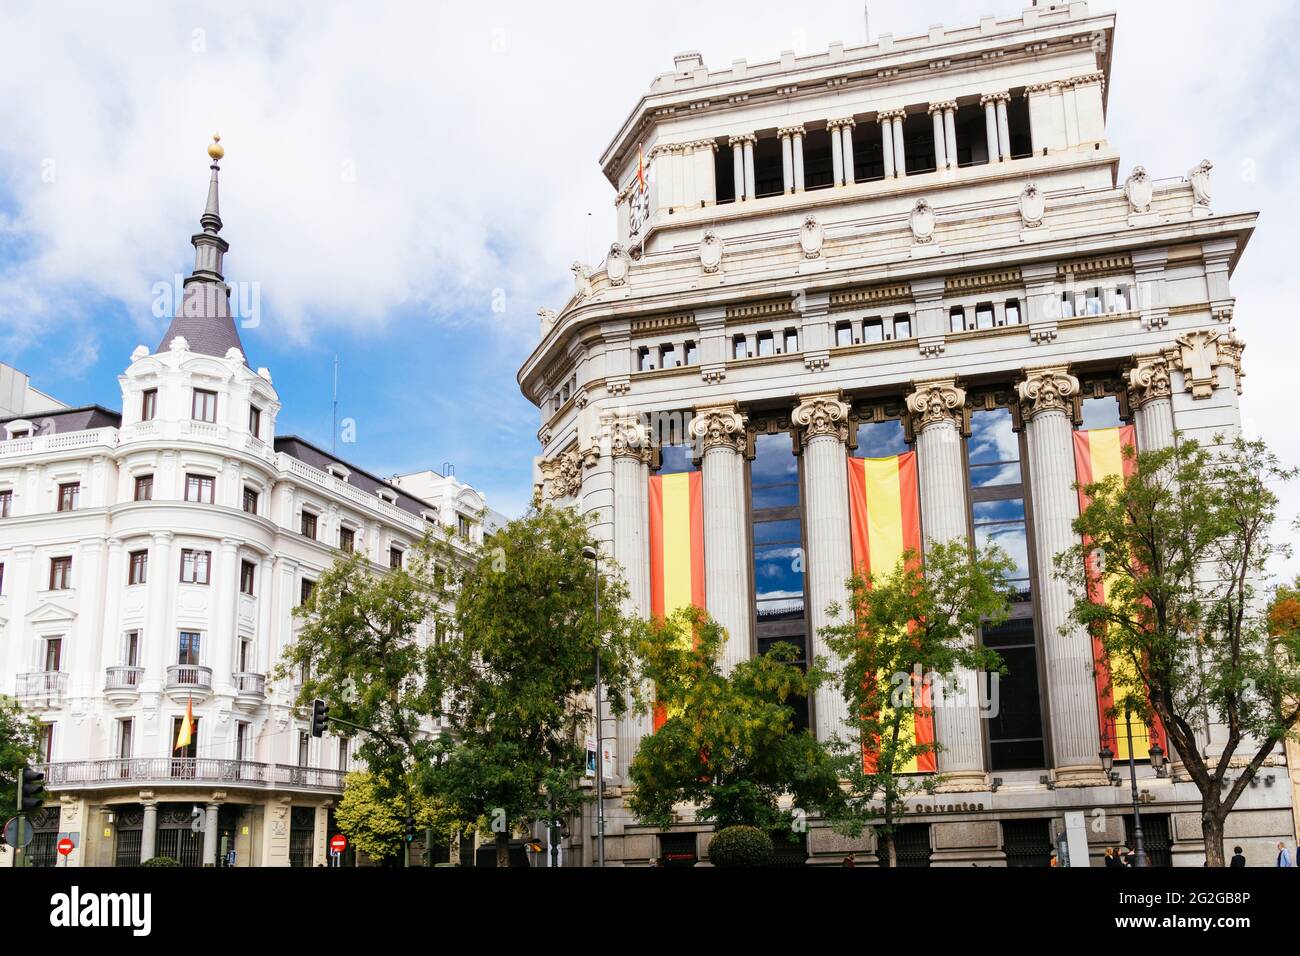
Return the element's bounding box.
[1056,438,1300,866]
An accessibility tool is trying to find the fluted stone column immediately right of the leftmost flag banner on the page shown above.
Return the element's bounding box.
[690,402,753,672]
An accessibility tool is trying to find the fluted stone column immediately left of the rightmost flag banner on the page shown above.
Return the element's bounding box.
[1017,365,1106,787]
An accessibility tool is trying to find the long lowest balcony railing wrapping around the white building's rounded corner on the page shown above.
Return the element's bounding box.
[40,757,347,793]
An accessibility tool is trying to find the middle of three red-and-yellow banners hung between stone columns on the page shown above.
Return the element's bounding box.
[849,451,937,774]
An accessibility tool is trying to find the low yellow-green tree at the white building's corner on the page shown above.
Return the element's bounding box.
[334,770,465,865]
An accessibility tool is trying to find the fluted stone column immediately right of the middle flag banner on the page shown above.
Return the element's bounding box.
[907,378,988,792]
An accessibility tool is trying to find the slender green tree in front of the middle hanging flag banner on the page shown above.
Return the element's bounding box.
[822,540,1014,866]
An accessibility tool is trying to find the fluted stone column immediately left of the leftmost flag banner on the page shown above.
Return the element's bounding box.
[601,415,651,780]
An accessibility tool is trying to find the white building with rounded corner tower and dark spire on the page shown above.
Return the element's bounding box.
[0,150,499,866]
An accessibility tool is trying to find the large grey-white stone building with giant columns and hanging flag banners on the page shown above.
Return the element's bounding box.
[519,1,1292,865]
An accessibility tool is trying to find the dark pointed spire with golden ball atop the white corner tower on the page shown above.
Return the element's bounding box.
[159,135,247,363]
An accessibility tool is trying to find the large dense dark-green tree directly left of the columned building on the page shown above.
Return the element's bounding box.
[426,507,636,866]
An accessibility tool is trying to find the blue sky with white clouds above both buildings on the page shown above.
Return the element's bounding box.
[0,0,1300,538]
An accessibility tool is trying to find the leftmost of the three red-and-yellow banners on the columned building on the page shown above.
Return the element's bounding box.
[649,471,705,730]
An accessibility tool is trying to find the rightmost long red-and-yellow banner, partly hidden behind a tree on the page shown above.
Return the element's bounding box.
[1074,425,1167,760]
